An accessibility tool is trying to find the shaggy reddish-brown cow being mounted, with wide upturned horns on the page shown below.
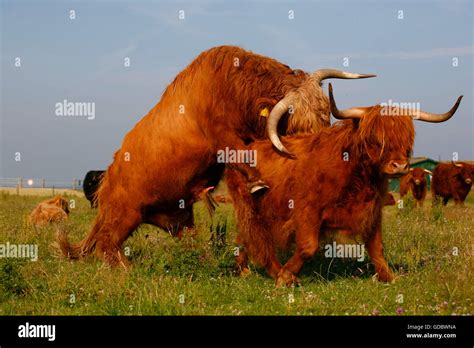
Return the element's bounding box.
[226,84,461,286]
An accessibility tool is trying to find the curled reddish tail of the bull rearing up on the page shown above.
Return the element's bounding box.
[55,215,102,260]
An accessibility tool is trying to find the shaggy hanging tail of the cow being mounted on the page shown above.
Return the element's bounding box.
[225,167,275,267]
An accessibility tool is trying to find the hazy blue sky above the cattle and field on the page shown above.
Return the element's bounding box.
[0,0,474,180]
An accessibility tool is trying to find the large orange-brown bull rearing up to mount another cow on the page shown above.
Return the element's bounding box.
[58,46,374,267]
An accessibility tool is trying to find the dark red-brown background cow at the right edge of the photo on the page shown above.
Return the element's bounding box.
[431,161,474,205]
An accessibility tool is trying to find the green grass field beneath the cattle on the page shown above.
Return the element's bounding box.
[0,192,474,315]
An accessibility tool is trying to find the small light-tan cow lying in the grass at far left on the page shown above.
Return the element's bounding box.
[30,196,69,227]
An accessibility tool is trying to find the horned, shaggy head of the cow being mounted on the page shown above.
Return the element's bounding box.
[329,84,462,177]
